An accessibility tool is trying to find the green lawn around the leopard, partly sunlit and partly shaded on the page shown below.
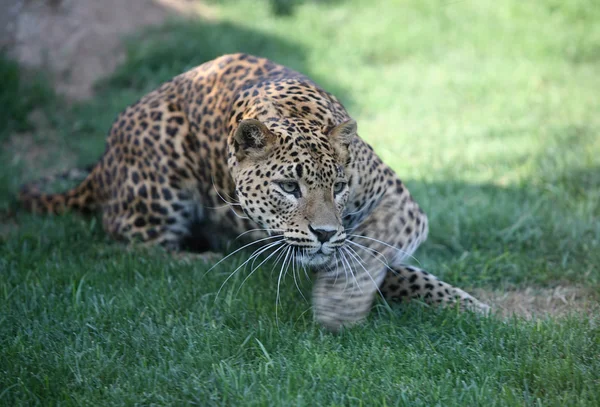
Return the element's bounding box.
[0,0,600,406]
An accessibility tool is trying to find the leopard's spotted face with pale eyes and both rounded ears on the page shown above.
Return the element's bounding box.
[229,119,356,269]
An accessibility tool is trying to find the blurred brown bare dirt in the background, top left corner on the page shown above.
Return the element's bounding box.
[0,0,216,100]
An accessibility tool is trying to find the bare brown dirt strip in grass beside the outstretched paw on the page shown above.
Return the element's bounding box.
[474,286,600,319]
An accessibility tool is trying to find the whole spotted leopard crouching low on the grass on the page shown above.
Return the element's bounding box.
[20,54,488,330]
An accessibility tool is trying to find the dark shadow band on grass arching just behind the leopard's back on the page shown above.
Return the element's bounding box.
[60,16,351,166]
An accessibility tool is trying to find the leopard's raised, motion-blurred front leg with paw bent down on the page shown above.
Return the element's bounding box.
[313,189,427,331]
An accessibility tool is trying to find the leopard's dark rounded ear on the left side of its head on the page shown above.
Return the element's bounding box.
[233,119,275,161]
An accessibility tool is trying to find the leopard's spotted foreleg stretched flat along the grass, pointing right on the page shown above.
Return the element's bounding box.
[380,265,490,313]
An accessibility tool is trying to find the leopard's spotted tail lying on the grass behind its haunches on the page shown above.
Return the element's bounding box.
[18,167,99,214]
